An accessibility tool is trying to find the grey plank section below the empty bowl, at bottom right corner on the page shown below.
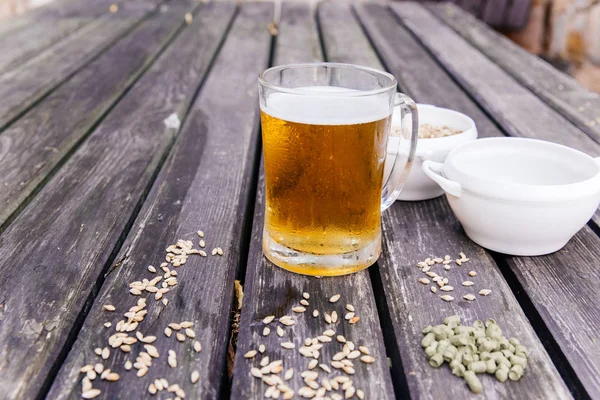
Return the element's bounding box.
[507,227,600,399]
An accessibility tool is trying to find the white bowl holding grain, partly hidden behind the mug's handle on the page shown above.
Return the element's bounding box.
[384,104,477,201]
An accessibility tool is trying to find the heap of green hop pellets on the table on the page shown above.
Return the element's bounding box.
[421,315,529,393]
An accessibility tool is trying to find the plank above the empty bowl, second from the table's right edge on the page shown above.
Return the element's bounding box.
[391,2,600,226]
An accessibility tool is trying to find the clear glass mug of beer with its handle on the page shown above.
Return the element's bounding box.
[258,63,418,276]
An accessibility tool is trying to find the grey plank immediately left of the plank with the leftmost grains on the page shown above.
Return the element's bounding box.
[0,5,237,399]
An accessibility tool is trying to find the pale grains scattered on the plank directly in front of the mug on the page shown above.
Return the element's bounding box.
[244,292,375,400]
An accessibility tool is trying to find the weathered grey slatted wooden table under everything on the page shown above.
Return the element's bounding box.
[0,0,600,400]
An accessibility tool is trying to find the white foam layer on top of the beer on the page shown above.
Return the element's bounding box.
[261,86,390,125]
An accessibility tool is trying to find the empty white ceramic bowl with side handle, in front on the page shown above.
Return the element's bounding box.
[423,138,600,256]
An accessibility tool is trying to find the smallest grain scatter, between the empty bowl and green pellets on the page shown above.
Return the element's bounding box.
[417,251,492,301]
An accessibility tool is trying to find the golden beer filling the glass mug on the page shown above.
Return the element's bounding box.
[261,88,390,275]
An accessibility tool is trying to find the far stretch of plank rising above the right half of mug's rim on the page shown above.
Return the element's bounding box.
[317,2,384,70]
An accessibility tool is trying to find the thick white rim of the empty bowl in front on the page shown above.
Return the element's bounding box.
[442,137,600,204]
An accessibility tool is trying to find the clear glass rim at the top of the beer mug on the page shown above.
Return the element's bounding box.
[258,62,398,97]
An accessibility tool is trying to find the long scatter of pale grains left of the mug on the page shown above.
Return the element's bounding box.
[80,231,219,400]
